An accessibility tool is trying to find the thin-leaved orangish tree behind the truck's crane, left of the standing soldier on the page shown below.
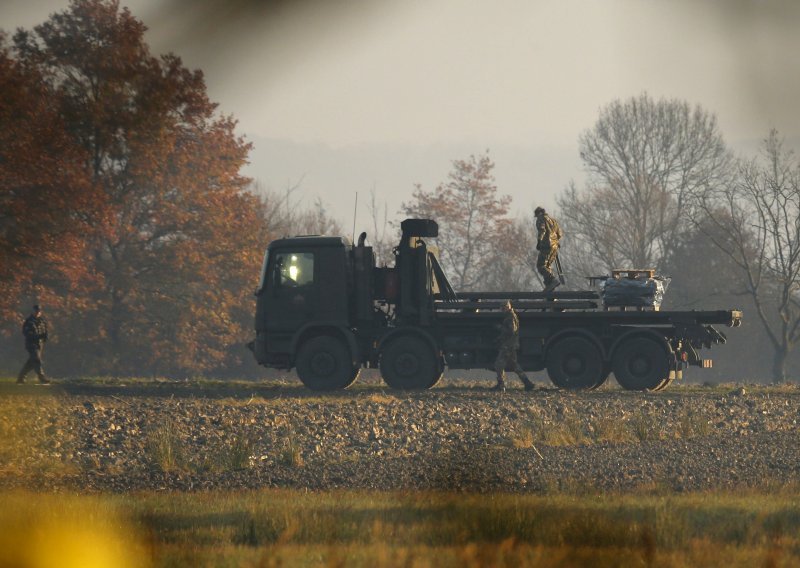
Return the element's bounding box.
[402,152,513,291]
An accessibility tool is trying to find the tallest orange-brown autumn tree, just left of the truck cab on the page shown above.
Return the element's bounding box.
[4,0,267,375]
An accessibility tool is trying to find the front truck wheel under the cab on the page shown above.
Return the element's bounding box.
[295,335,360,391]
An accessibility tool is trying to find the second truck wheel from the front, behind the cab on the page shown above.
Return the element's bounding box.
[380,336,442,390]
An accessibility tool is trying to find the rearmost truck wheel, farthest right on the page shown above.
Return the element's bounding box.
[611,336,669,391]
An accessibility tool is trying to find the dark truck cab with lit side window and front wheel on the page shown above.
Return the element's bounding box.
[253,236,374,390]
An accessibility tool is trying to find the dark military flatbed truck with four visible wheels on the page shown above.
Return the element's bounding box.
[251,219,742,391]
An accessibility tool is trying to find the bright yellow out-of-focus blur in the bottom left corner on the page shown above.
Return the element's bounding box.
[0,493,150,568]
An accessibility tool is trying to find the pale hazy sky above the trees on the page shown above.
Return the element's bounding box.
[0,0,800,226]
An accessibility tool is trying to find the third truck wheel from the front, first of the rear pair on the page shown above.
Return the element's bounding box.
[545,336,608,390]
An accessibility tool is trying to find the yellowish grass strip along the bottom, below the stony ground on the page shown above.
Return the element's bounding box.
[0,487,800,568]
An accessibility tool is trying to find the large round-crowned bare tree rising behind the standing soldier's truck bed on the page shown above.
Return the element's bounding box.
[558,93,731,269]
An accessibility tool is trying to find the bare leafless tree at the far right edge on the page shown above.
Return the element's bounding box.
[697,130,800,381]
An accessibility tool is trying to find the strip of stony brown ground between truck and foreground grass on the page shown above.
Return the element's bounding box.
[0,380,800,492]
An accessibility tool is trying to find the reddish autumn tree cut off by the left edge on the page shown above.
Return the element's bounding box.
[0,34,104,327]
